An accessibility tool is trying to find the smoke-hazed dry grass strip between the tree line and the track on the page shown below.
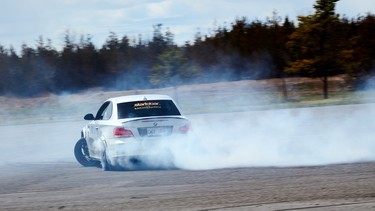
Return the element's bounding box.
[0,76,375,125]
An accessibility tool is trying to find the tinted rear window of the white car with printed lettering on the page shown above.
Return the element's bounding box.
[117,100,181,119]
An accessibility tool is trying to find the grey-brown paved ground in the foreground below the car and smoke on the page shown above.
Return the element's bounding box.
[0,162,375,210]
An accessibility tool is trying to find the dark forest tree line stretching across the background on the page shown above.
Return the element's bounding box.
[0,0,375,98]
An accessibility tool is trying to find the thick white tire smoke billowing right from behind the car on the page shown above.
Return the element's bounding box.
[125,104,375,170]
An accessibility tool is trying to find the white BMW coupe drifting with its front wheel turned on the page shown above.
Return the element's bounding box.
[74,95,190,170]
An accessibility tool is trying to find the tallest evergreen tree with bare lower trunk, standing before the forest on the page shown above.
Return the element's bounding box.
[285,0,341,99]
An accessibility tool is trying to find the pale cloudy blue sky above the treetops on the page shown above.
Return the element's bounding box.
[0,0,375,49]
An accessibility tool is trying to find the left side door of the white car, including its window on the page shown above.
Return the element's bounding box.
[87,101,112,158]
